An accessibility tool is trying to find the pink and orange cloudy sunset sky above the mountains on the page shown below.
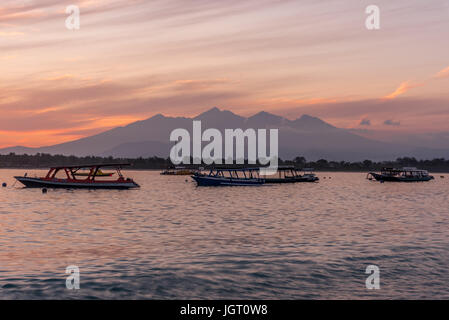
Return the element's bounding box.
[0,0,449,147]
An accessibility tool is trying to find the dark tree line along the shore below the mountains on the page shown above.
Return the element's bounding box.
[0,153,449,172]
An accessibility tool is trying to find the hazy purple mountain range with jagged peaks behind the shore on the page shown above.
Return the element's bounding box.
[0,107,449,161]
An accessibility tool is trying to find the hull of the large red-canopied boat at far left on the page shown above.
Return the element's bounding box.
[14,177,140,189]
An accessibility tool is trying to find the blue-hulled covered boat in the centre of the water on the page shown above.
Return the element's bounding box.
[192,168,265,187]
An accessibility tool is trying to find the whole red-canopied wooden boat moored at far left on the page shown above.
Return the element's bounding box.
[14,163,140,189]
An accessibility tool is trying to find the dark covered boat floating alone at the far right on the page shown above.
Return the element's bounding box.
[367,167,434,182]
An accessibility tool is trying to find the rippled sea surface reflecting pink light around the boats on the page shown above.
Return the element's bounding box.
[0,170,449,299]
